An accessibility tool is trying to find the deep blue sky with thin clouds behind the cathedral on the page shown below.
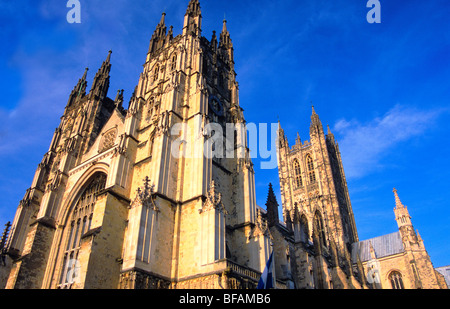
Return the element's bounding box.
[0,0,450,267]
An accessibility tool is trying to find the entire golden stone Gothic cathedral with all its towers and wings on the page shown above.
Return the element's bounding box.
[0,0,444,289]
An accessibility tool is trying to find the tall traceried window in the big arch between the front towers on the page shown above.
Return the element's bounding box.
[59,173,106,288]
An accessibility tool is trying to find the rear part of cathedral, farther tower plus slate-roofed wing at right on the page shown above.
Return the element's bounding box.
[274,108,447,289]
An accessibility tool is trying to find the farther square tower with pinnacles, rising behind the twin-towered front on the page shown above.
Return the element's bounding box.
[277,107,365,288]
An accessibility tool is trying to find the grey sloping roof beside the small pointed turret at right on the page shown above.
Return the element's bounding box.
[352,231,405,263]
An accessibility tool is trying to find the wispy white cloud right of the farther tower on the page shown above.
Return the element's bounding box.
[334,105,443,178]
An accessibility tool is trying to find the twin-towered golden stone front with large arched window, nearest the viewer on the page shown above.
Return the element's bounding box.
[2,0,270,288]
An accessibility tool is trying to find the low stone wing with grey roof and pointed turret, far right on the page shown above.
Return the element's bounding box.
[353,189,447,289]
